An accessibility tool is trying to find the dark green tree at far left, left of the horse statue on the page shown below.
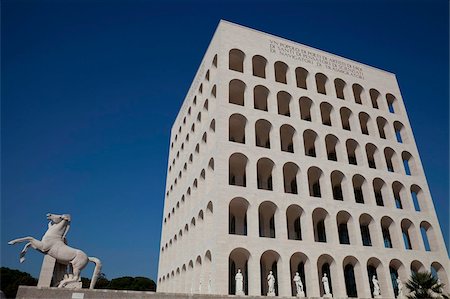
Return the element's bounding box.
[0,267,37,298]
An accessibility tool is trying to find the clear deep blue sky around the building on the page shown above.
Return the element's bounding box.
[0,0,449,280]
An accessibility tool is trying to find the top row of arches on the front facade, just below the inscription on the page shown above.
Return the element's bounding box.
[228,49,400,113]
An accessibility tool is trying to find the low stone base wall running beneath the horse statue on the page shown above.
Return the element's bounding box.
[16,286,394,299]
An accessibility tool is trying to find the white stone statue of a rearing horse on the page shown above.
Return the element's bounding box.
[8,214,102,289]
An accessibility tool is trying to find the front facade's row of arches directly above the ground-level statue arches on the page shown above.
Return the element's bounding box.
[228,197,441,251]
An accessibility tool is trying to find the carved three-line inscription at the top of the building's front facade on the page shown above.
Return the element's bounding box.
[269,40,364,79]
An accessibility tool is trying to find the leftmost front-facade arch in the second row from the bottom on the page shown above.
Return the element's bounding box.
[228,197,250,236]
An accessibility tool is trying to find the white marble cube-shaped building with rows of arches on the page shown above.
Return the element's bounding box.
[158,21,450,298]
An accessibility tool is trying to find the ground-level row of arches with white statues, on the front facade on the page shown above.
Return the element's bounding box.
[228,247,448,298]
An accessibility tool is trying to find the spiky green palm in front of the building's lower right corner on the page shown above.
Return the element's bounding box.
[406,271,449,299]
